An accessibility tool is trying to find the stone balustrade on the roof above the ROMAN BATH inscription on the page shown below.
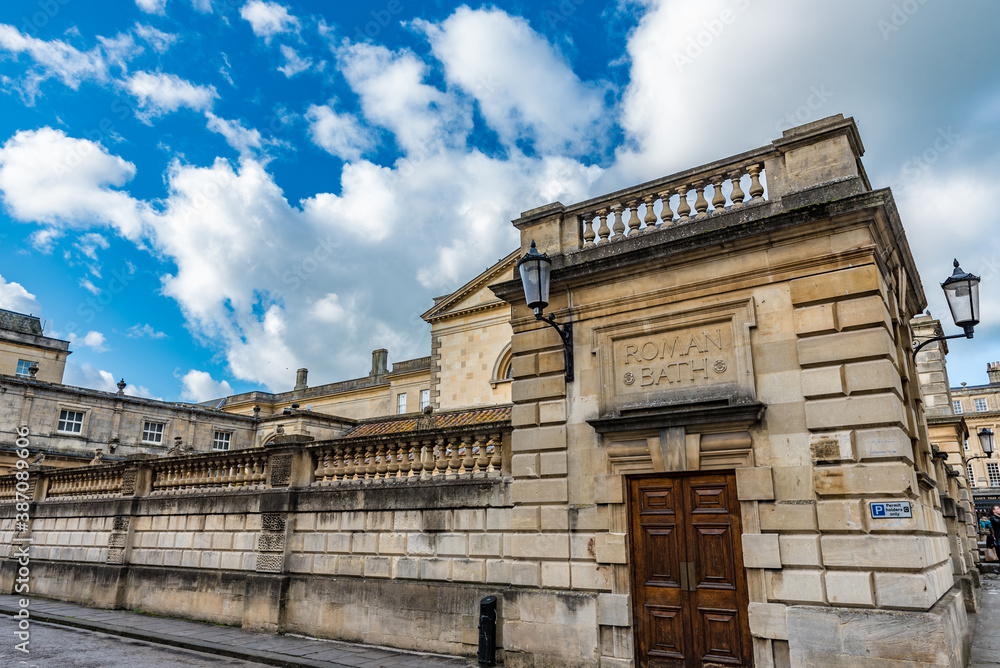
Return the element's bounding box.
[566,162,766,249]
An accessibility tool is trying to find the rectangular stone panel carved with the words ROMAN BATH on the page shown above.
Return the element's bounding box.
[614,322,737,395]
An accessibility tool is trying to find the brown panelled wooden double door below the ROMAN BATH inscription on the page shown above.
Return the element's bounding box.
[629,472,753,668]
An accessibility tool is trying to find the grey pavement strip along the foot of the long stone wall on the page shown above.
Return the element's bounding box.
[0,596,476,668]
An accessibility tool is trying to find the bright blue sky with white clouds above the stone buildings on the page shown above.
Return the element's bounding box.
[0,0,1000,400]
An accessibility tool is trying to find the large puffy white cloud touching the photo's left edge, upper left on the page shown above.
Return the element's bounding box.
[0,127,142,240]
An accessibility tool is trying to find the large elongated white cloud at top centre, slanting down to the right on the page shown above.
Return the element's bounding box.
[416,7,608,153]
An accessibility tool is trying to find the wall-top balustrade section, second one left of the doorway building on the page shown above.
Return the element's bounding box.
[152,449,268,494]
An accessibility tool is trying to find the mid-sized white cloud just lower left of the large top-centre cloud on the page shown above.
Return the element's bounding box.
[337,43,472,157]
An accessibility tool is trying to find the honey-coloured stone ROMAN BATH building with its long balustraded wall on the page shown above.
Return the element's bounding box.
[0,116,976,668]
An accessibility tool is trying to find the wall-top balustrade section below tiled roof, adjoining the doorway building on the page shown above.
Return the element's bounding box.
[311,432,503,485]
